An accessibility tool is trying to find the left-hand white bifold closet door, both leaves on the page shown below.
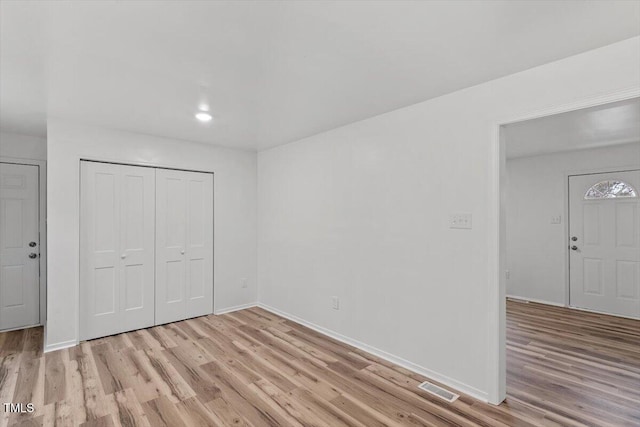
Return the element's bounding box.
[80,161,155,340]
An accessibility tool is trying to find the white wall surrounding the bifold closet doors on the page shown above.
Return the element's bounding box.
[45,120,257,350]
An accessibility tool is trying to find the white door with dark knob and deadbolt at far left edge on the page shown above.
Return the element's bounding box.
[0,163,40,330]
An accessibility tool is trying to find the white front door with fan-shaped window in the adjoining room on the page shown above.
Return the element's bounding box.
[569,171,640,318]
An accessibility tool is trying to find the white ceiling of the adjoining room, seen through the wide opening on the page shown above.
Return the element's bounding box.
[503,98,640,160]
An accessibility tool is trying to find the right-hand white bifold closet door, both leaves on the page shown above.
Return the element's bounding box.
[156,169,213,324]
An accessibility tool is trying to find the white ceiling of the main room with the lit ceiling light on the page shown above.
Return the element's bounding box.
[0,0,640,149]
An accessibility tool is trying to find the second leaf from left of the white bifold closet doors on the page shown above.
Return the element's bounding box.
[120,166,156,330]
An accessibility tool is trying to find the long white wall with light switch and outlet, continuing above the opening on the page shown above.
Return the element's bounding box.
[258,38,640,401]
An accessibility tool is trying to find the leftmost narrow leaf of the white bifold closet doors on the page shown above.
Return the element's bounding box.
[80,162,121,340]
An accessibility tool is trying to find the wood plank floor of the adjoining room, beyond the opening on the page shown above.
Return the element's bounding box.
[507,302,640,426]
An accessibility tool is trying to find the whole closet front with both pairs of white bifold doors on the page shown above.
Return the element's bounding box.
[80,161,213,340]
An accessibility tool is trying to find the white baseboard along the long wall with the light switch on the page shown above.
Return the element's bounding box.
[257,302,489,403]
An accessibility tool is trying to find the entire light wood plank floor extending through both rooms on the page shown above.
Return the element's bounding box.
[0,302,640,427]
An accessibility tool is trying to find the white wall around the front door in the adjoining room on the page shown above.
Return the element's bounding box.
[506,145,640,305]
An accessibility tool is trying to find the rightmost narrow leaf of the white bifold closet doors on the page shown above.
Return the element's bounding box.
[186,172,213,317]
